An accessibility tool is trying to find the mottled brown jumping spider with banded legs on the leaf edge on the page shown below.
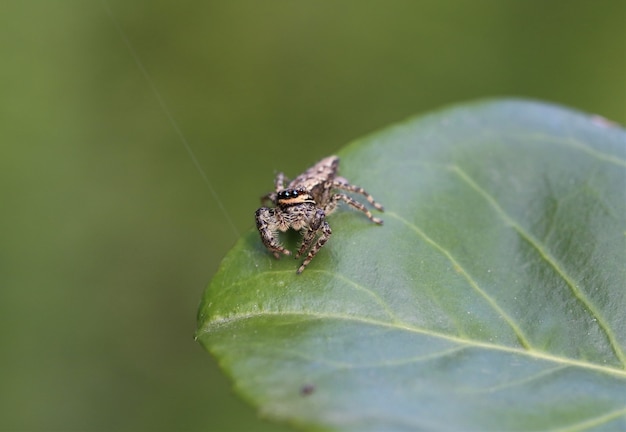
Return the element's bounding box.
[256,156,383,273]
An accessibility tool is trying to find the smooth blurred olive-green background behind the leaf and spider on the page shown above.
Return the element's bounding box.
[0,0,626,431]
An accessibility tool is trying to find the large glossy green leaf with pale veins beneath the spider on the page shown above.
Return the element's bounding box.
[197,100,626,431]
